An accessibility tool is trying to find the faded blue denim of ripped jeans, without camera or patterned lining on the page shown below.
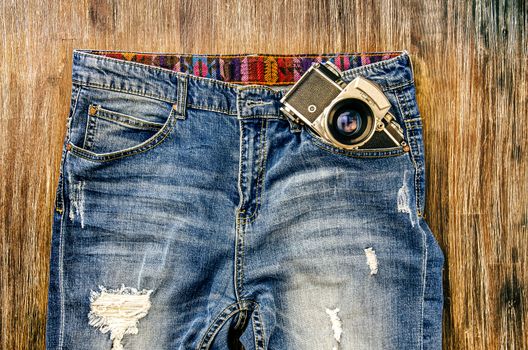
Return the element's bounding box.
[46,50,444,350]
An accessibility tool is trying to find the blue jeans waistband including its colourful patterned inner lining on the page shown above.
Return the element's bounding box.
[72,50,413,118]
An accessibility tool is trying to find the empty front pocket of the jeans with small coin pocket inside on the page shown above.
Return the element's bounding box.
[68,86,178,161]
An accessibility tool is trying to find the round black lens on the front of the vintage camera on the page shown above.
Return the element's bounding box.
[327,98,374,145]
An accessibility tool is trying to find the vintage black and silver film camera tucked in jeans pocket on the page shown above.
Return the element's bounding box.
[281,61,408,150]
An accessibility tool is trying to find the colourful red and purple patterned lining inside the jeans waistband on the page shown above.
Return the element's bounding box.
[91,51,401,85]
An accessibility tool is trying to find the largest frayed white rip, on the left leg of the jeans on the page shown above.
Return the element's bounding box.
[88,285,152,350]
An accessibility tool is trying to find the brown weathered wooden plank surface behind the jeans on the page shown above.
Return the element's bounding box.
[0,0,528,350]
